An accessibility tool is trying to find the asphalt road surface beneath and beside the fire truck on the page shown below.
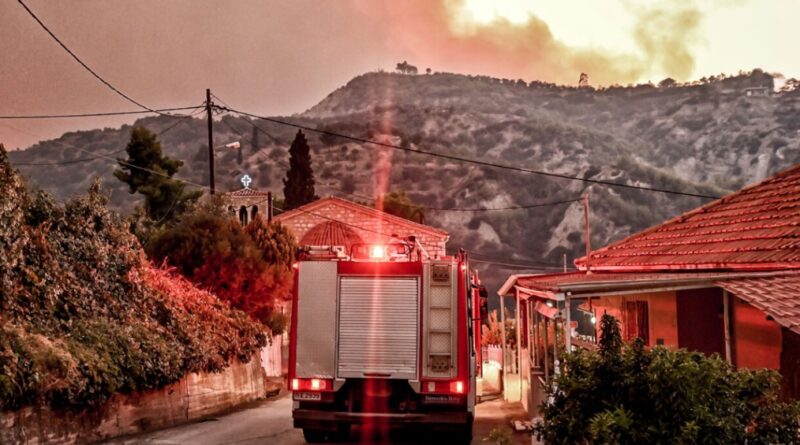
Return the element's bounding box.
[105,395,531,445]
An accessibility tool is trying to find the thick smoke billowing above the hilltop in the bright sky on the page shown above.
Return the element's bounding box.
[359,0,702,85]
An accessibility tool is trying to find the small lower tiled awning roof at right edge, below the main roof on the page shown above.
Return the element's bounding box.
[715,274,800,334]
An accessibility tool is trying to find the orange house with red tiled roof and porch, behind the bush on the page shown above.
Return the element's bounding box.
[498,166,800,411]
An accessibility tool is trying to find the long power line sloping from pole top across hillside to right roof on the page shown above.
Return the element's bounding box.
[216,105,719,199]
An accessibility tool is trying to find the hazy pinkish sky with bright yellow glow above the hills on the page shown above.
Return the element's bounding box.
[0,0,800,148]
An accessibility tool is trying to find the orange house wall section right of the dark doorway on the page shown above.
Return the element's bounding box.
[731,298,783,370]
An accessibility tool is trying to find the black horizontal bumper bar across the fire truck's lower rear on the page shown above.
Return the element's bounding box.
[292,409,472,428]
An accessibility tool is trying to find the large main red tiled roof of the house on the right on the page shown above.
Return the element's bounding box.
[575,166,800,271]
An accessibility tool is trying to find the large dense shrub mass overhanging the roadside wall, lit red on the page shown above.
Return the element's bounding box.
[0,146,266,410]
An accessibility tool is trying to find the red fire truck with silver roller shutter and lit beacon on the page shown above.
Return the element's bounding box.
[289,237,486,443]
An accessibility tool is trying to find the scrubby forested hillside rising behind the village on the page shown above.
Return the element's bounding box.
[11,70,800,290]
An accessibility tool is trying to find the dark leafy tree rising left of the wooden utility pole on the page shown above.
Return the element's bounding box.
[114,127,202,225]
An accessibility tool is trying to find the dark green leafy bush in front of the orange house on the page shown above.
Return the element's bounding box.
[536,315,800,445]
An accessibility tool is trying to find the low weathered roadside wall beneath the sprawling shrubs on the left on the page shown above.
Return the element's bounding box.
[0,356,265,445]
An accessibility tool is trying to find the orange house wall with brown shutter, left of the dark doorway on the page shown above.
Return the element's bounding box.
[592,292,678,348]
